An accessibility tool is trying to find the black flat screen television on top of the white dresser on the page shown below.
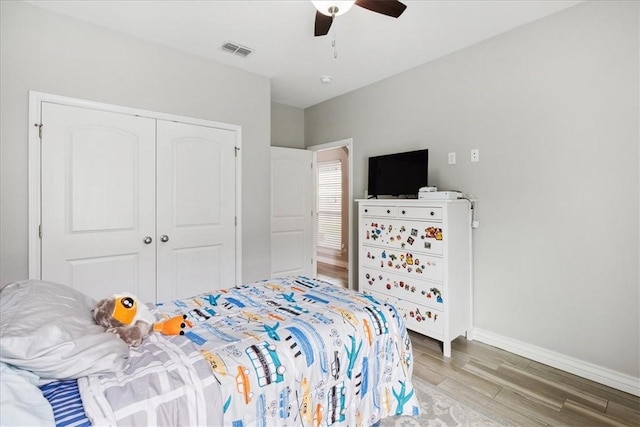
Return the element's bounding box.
[368,149,429,197]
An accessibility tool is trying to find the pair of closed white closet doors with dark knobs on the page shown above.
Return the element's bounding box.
[41,103,235,302]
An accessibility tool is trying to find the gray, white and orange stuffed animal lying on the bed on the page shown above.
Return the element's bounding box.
[91,294,192,347]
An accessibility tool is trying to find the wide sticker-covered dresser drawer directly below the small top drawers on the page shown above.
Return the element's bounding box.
[358,218,445,255]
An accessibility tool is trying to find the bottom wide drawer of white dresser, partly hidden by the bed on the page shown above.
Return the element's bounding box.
[367,292,444,340]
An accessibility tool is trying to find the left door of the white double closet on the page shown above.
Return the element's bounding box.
[41,102,156,301]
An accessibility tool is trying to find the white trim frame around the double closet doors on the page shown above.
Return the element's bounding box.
[28,91,242,286]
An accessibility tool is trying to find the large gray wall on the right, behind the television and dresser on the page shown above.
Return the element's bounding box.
[305,2,640,378]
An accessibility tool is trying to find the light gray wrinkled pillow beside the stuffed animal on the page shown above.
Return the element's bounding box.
[0,280,129,379]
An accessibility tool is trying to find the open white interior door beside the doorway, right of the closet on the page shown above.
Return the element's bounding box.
[271,147,316,277]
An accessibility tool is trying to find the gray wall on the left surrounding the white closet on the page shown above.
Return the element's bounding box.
[0,1,271,284]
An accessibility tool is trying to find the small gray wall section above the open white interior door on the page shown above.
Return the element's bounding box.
[271,102,305,148]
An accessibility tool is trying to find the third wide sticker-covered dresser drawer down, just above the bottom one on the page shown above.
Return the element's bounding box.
[358,267,445,310]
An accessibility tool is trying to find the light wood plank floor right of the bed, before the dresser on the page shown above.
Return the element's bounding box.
[410,331,640,426]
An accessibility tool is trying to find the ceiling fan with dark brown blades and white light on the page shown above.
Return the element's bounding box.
[311,0,407,37]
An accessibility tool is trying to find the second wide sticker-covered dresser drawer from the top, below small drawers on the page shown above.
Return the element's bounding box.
[360,246,444,281]
